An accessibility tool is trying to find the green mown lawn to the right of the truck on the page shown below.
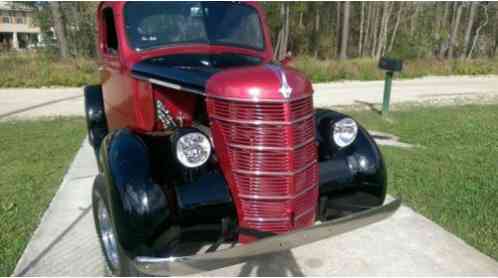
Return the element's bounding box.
[349,105,498,259]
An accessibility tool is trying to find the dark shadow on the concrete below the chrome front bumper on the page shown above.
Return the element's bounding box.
[239,251,304,277]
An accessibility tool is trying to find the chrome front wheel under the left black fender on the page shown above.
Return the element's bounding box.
[98,198,119,269]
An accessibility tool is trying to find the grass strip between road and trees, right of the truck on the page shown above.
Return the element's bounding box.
[292,56,498,82]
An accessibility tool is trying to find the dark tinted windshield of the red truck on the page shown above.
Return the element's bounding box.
[125,2,264,51]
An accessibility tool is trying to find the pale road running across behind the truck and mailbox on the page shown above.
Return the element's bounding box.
[0,76,498,120]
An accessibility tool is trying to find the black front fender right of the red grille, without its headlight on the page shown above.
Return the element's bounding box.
[315,109,387,211]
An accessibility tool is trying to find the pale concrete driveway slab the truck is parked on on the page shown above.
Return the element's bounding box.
[14,140,498,276]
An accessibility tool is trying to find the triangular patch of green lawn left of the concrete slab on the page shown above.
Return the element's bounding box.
[0,118,85,276]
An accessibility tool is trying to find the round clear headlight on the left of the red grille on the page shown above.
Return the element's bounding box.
[176,131,211,168]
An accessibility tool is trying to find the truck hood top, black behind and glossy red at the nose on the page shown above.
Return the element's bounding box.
[132,56,312,100]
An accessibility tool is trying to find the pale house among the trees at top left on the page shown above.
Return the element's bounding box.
[0,2,41,51]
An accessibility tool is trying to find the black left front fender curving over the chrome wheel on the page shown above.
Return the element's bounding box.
[100,129,170,256]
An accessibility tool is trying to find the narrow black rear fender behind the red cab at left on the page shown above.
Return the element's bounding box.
[84,85,108,165]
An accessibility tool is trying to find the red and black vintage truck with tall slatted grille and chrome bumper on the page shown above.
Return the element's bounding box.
[85,2,400,276]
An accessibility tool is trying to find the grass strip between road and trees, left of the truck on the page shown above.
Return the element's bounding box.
[0,53,98,88]
